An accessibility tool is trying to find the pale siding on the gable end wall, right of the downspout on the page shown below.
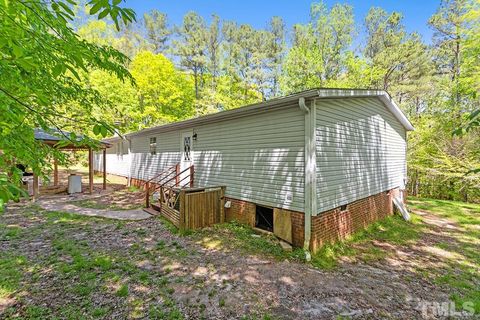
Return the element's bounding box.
[315,98,406,212]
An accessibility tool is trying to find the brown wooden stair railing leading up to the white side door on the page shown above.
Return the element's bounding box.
[145,165,195,209]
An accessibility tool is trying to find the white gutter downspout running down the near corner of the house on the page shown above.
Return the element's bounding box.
[298,97,316,261]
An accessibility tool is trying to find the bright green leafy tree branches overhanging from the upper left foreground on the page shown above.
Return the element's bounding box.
[0,0,135,207]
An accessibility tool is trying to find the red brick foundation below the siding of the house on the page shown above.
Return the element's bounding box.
[225,189,401,252]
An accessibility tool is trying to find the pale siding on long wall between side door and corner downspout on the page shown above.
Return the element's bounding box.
[193,105,305,211]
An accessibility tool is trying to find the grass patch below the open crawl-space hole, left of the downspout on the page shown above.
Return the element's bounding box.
[192,222,304,261]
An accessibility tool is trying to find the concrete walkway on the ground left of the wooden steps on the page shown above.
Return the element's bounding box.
[37,199,152,220]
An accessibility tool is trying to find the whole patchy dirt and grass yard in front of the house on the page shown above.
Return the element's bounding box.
[0,199,480,319]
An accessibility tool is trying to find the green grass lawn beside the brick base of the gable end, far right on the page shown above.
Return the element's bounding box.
[312,197,480,313]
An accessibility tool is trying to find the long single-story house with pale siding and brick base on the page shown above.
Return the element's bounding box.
[96,89,413,251]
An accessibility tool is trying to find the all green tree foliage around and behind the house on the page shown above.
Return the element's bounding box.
[0,0,480,205]
